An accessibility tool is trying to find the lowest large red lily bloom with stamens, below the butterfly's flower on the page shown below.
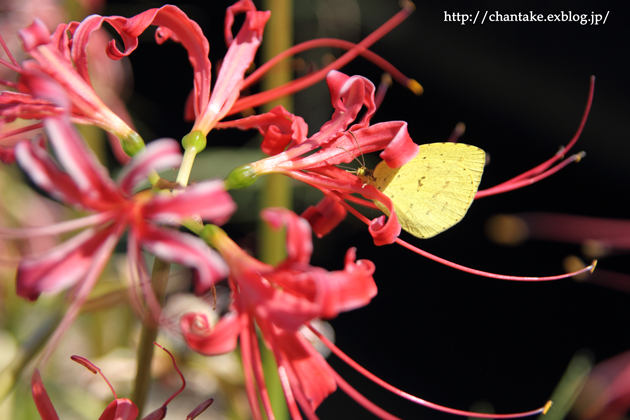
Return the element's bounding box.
[180,209,548,419]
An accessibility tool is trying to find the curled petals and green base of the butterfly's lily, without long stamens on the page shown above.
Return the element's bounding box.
[222,70,418,245]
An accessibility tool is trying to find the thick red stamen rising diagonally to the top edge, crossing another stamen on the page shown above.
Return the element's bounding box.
[227,2,414,115]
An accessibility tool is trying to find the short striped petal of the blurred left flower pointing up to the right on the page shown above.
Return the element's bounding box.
[118,139,182,195]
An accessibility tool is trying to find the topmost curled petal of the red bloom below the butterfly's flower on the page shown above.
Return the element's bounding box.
[261,208,313,263]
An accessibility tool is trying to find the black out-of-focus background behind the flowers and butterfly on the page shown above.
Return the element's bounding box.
[105,0,630,419]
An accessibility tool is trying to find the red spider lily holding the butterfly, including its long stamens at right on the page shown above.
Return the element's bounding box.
[221,70,594,281]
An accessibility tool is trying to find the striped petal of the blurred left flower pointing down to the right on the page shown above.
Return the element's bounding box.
[138,223,228,295]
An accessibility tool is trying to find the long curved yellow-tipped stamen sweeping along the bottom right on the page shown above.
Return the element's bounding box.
[306,324,551,419]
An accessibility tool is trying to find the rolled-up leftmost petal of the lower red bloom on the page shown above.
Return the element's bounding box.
[184,312,240,356]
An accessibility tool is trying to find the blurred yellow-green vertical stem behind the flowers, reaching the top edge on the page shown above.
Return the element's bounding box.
[258,0,293,420]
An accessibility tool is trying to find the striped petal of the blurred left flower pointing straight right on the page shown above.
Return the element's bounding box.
[142,180,236,224]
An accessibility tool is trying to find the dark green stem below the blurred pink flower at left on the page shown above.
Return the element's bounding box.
[131,257,171,414]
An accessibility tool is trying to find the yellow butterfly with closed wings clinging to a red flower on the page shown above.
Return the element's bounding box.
[357,143,486,238]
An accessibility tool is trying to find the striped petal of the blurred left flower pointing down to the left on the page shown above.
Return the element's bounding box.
[16,225,120,300]
